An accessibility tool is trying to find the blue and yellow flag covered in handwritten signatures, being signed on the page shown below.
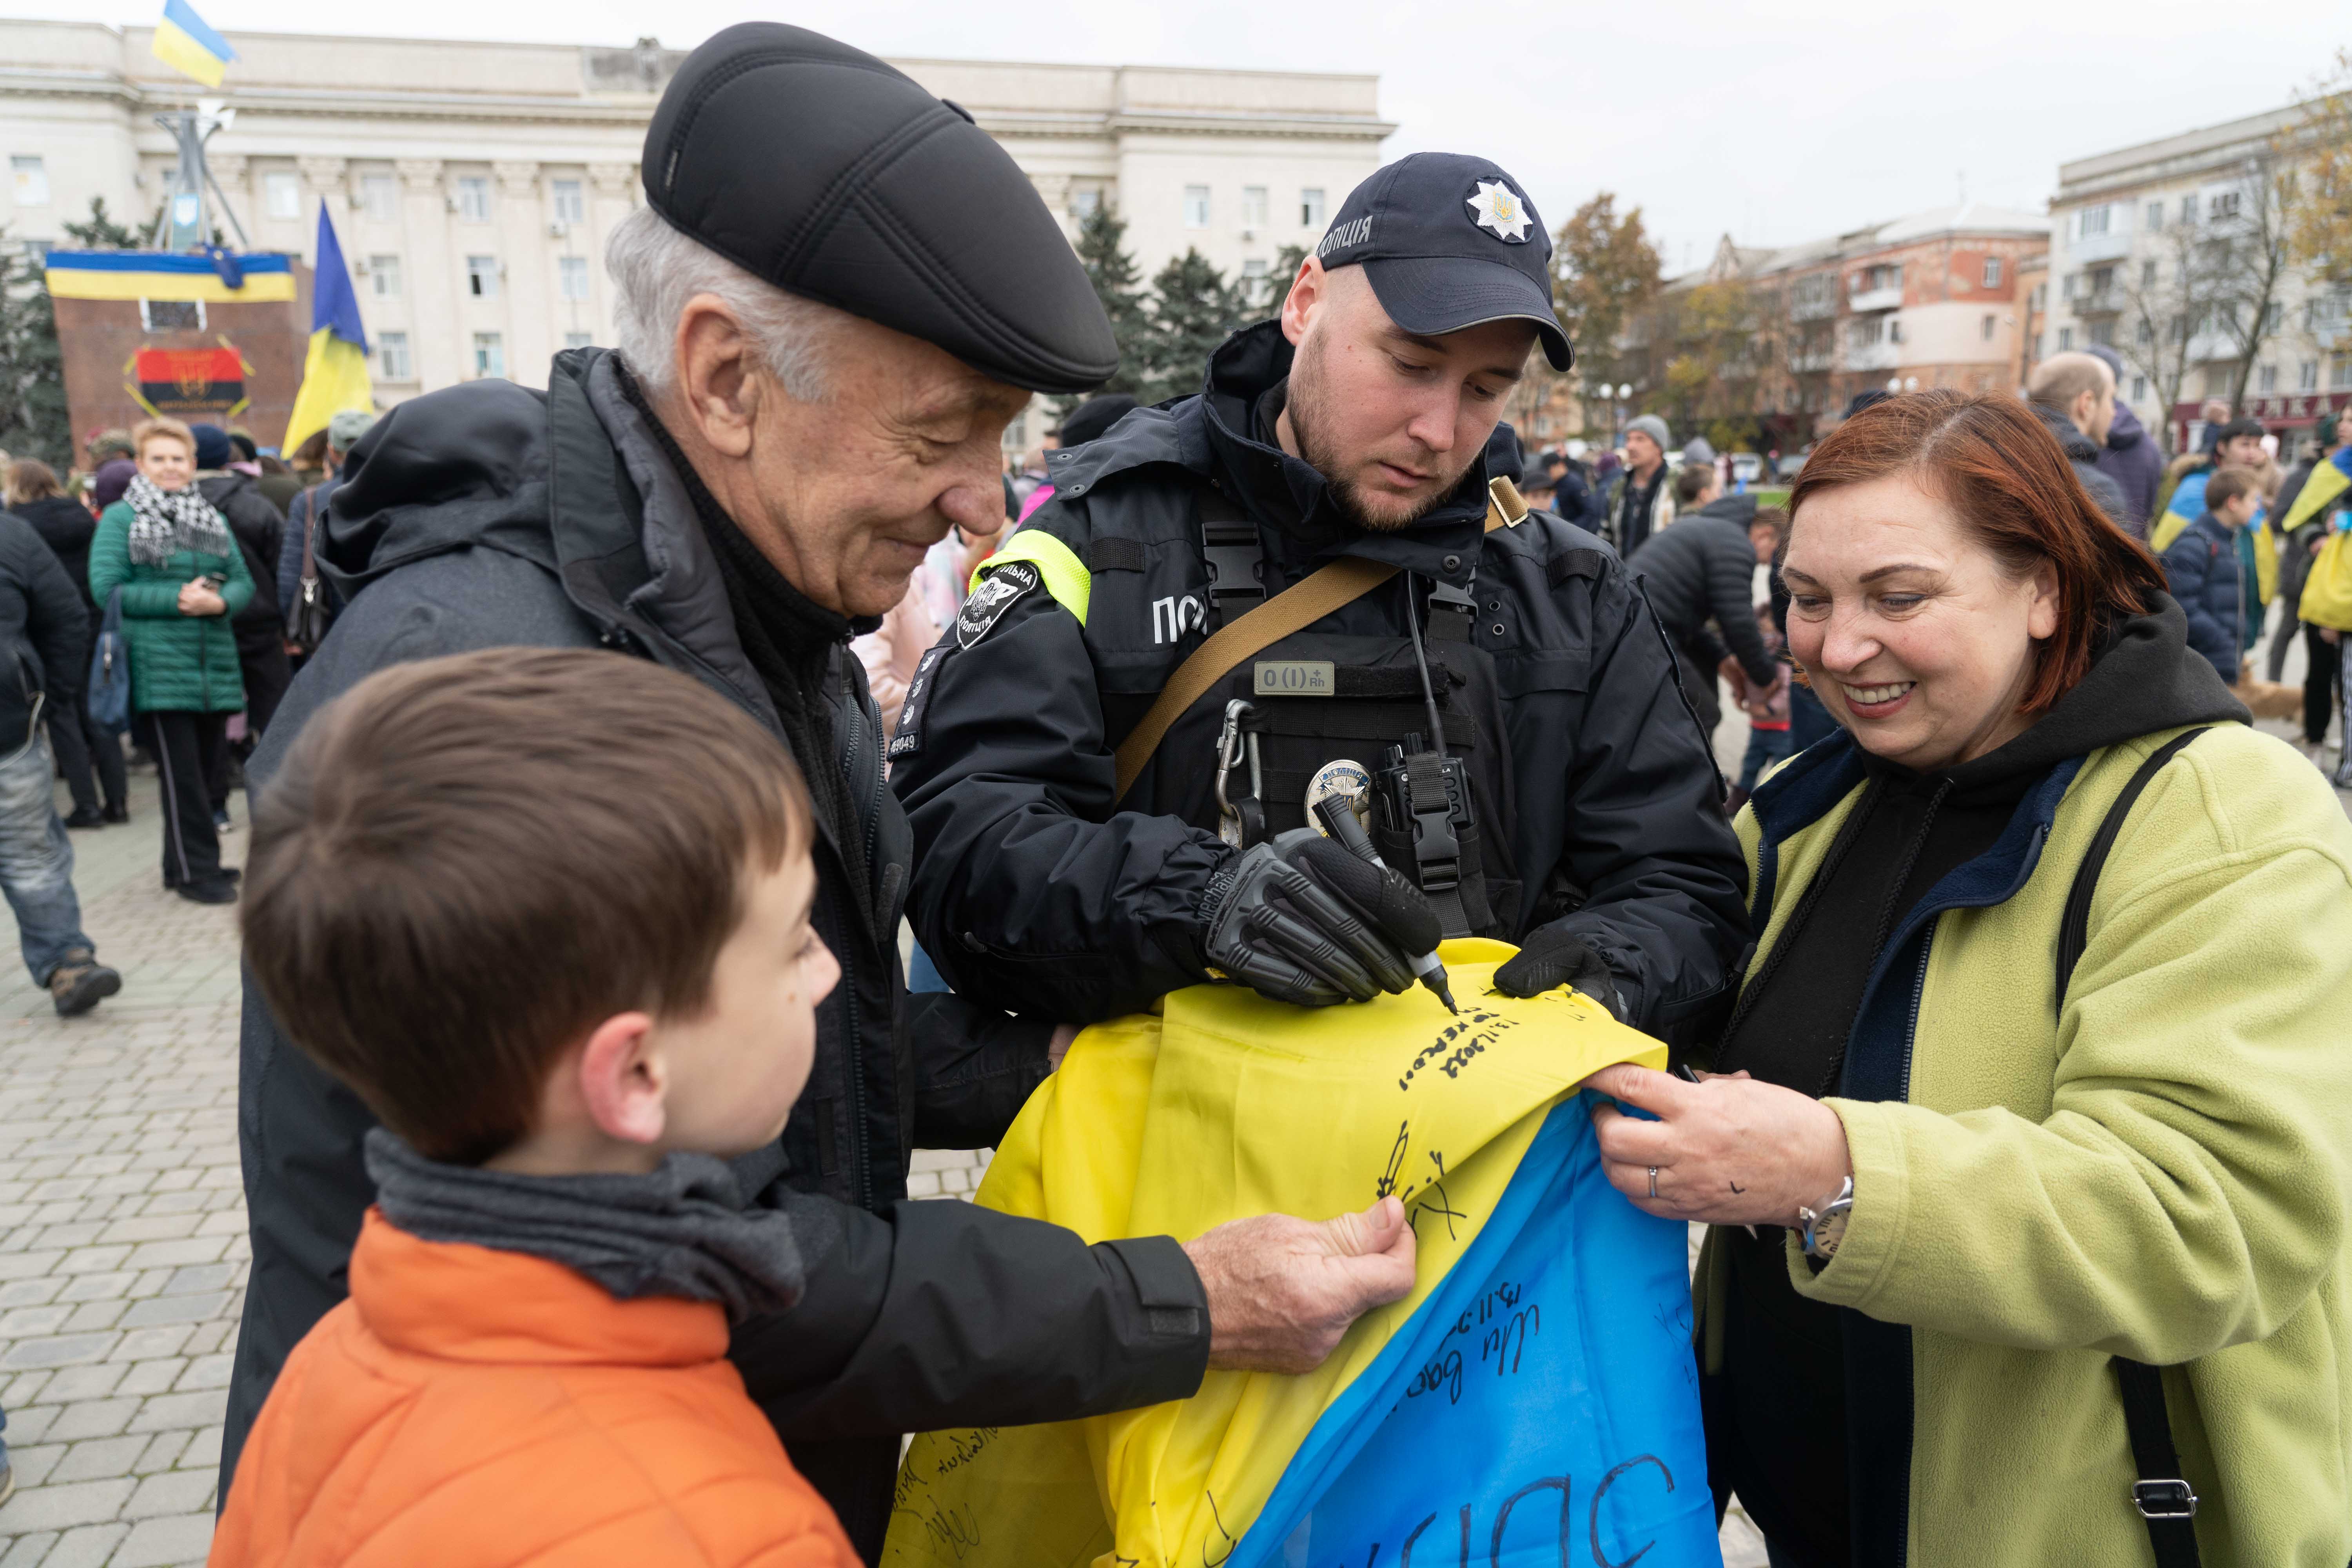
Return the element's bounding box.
[882,940,1719,1568]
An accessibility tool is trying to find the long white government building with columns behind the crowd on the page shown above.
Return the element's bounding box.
[0,21,1395,446]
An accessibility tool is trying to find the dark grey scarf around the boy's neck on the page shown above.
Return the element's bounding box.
[367,1126,802,1323]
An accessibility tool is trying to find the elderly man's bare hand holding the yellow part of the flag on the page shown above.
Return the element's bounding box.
[1183,1196,1414,1373]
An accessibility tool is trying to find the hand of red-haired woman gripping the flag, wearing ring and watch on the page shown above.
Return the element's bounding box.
[1583,1065,1853,1225]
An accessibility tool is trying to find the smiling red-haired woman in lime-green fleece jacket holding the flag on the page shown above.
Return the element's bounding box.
[1595,392,2352,1568]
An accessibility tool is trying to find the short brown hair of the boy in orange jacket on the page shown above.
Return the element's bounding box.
[242,649,811,1164]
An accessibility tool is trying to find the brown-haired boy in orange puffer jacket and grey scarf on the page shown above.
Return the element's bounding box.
[212,649,856,1568]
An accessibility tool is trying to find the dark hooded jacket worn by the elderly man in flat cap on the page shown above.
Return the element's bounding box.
[221,348,1209,1497]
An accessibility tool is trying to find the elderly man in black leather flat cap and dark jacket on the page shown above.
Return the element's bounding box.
[221,24,1411,1561]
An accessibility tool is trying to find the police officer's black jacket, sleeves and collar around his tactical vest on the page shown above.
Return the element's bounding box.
[891,322,1748,1030]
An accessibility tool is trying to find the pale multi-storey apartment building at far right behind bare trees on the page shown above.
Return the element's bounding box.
[2037,108,2352,449]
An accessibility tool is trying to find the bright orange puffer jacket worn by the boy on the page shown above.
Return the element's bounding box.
[212,1208,858,1568]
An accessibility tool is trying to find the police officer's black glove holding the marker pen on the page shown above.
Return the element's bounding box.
[1200,828,1444,1006]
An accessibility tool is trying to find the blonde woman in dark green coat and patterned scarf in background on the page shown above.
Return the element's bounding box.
[89,418,254,903]
